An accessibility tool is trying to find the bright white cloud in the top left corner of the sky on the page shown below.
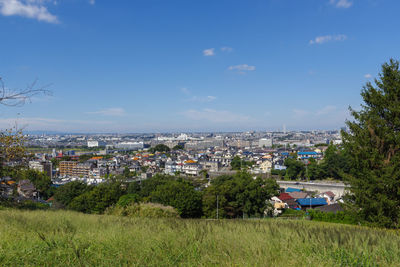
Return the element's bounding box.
[0,0,59,23]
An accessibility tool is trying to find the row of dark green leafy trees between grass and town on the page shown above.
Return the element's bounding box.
[54,172,279,218]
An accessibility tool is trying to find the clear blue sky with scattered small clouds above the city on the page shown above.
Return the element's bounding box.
[0,0,400,132]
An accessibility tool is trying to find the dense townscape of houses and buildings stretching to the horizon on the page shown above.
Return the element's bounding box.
[1,131,345,216]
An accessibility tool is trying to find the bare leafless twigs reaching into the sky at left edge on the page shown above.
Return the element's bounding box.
[0,77,51,107]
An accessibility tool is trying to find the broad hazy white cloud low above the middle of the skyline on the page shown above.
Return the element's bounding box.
[183,108,251,123]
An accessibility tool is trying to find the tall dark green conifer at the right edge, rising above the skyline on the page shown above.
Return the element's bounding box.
[342,59,400,228]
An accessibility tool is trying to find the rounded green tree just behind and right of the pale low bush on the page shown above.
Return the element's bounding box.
[150,180,202,218]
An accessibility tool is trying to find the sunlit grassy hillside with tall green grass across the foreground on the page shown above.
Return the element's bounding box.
[0,210,400,266]
